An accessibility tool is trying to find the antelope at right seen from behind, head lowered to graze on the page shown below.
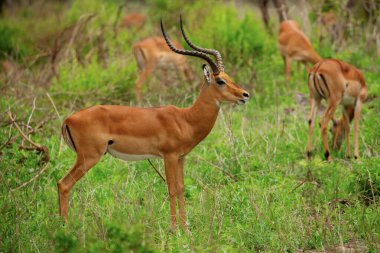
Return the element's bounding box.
[307,59,367,161]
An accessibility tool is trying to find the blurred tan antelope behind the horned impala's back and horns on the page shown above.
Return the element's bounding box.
[133,37,193,103]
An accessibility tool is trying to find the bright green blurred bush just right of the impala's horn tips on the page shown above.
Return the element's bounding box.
[187,5,272,65]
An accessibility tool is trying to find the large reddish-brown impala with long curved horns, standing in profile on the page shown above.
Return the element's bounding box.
[58,19,249,229]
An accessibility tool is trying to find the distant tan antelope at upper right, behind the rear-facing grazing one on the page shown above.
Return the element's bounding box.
[278,20,322,81]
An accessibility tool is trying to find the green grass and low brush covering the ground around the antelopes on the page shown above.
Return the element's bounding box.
[0,0,380,252]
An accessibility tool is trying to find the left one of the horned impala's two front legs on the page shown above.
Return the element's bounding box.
[164,155,178,230]
